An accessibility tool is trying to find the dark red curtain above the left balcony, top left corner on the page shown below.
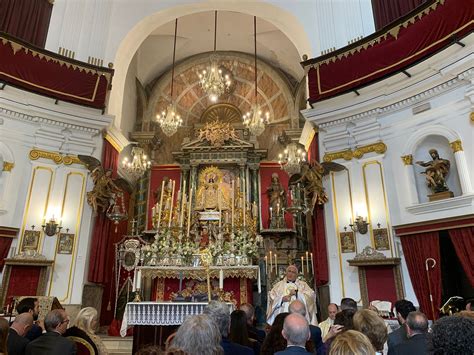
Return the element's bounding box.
[0,0,53,48]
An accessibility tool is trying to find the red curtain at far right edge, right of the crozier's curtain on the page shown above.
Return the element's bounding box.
[449,227,474,287]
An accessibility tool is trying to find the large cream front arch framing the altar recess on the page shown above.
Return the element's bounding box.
[108,0,313,132]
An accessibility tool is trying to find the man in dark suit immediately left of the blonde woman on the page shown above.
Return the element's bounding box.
[25,309,77,355]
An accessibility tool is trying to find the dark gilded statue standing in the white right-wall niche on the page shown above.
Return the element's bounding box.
[416,149,454,201]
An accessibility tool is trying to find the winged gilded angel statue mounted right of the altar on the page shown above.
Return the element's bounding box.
[296,161,346,213]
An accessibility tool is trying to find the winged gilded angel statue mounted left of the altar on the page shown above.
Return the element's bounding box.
[77,155,132,214]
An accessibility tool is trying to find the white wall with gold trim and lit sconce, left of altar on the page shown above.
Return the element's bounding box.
[0,86,112,304]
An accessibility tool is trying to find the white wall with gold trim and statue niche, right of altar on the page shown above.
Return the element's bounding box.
[303,35,474,303]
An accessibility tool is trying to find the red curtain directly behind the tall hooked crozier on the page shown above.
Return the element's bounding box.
[400,231,441,319]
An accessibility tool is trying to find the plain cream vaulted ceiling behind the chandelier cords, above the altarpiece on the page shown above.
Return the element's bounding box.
[137,11,304,85]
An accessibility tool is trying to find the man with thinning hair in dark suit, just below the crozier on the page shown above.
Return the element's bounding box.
[394,312,428,355]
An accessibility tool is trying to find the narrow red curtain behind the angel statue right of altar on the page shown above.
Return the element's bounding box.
[308,133,329,286]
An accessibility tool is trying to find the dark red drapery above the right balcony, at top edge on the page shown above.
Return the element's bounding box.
[372,0,426,31]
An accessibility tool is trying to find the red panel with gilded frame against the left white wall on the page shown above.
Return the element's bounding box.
[0,256,54,307]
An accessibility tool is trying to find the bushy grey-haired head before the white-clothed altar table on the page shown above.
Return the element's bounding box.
[169,314,224,355]
